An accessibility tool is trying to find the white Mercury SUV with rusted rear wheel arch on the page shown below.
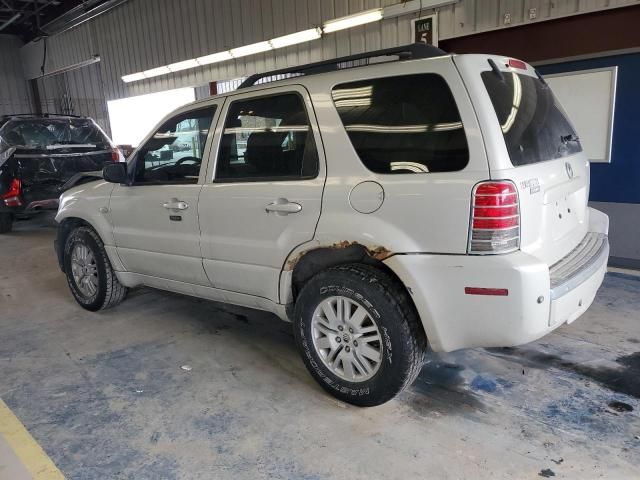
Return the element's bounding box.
[56,45,609,405]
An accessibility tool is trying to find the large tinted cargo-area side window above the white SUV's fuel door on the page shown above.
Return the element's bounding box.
[332,73,469,174]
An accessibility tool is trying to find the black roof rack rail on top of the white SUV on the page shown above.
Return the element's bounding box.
[238,43,447,90]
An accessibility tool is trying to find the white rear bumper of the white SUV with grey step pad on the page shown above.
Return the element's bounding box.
[385,208,609,351]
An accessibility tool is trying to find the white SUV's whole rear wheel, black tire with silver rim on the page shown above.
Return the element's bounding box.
[294,264,426,406]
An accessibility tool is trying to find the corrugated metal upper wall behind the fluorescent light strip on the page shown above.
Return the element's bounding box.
[23,0,639,105]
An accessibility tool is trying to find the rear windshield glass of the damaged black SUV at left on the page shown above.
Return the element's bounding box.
[1,118,110,150]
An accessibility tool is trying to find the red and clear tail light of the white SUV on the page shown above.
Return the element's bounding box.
[468,180,520,254]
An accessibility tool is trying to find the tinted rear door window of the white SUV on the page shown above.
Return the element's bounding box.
[216,93,318,182]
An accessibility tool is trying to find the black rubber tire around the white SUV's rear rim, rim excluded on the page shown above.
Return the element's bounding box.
[294,264,427,407]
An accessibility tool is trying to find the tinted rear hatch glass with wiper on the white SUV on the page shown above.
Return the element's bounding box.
[481,71,582,167]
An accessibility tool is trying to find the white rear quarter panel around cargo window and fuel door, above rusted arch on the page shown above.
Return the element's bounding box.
[304,57,489,254]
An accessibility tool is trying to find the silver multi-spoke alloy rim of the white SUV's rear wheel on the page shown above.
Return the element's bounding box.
[311,296,383,383]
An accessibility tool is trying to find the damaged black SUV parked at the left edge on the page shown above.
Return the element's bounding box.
[0,114,124,233]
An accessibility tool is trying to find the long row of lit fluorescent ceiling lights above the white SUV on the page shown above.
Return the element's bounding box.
[122,0,458,83]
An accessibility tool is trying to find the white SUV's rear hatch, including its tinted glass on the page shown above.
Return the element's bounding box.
[455,55,589,265]
